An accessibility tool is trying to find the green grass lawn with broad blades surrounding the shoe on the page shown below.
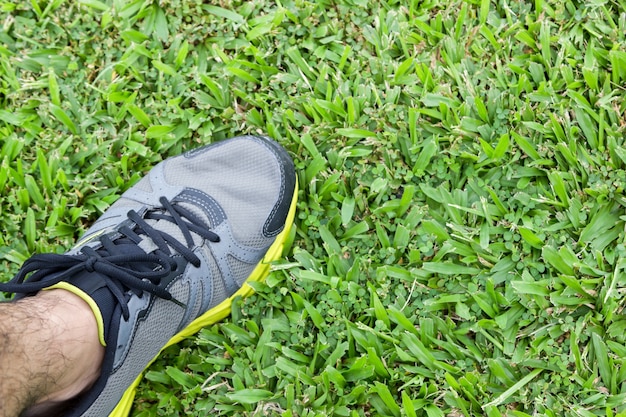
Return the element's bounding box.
[0,0,626,417]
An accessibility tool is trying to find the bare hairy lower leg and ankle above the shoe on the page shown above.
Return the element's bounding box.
[0,289,104,417]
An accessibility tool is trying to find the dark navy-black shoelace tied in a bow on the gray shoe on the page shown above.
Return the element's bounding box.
[0,197,220,319]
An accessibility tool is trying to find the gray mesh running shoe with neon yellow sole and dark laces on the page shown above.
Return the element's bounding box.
[0,136,297,417]
